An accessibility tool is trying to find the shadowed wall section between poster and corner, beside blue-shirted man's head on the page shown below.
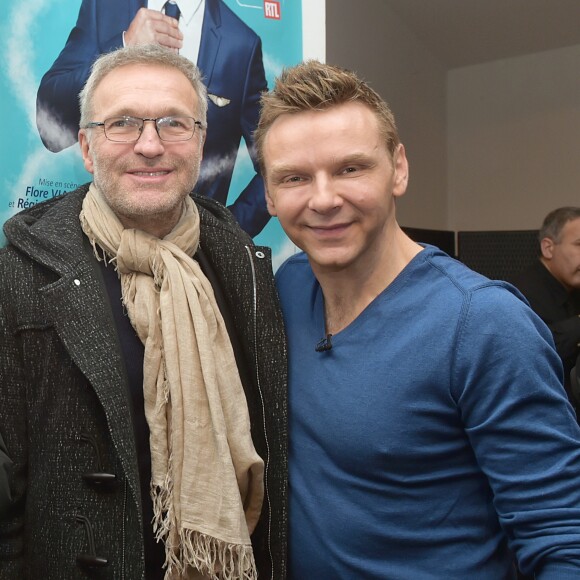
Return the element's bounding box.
[326,0,448,229]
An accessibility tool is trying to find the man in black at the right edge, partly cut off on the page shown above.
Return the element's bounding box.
[510,207,580,409]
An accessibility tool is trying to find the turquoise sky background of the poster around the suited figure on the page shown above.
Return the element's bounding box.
[0,0,324,262]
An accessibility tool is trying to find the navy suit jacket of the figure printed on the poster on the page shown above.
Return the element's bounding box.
[36,0,270,236]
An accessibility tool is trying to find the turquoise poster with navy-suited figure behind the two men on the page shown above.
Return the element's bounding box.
[0,0,324,267]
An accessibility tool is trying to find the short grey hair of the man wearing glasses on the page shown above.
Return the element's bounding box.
[79,44,207,127]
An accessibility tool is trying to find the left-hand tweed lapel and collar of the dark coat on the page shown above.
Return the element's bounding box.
[16,187,140,500]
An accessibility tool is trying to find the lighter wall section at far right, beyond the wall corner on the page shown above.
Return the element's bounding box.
[447,46,580,230]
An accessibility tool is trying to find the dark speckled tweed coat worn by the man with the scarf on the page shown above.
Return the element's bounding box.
[0,186,287,580]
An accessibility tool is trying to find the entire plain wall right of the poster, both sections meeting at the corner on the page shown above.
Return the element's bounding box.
[326,0,580,230]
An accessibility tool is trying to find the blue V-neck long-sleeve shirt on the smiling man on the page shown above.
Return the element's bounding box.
[277,247,580,580]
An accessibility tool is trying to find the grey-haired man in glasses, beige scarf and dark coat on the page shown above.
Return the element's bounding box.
[0,45,287,580]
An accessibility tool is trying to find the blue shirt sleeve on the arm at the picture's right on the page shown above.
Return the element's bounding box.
[451,286,580,580]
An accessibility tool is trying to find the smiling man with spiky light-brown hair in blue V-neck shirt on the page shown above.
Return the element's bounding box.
[255,61,580,580]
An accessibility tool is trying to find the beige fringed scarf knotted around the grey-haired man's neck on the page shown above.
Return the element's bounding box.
[80,184,264,580]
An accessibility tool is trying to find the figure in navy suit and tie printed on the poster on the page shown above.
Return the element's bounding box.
[36,0,270,236]
